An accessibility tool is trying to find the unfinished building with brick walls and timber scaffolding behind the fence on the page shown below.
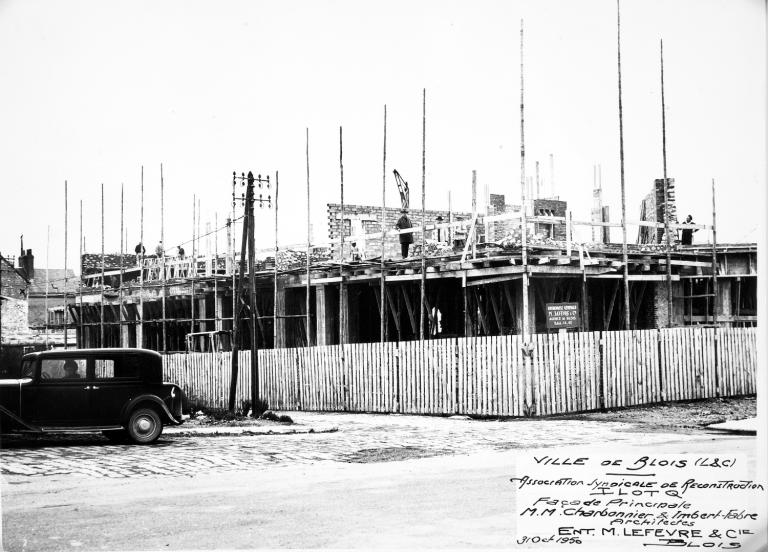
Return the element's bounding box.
[67,180,757,352]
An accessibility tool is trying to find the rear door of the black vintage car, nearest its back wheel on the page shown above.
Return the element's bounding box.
[89,354,144,426]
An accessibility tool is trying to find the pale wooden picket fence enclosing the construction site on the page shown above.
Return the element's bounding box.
[164,327,757,416]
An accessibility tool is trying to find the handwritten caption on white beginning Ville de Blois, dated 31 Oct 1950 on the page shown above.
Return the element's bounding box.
[510,455,766,552]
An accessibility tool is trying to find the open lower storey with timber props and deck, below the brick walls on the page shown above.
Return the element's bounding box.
[68,239,757,351]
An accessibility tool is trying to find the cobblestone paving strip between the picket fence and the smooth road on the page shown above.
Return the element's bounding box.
[0,412,716,478]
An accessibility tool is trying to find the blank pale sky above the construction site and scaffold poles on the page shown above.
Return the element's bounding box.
[0,0,766,274]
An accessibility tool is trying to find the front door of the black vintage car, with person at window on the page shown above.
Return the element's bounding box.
[27,357,91,427]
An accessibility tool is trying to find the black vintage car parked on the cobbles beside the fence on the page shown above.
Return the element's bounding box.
[0,349,185,444]
